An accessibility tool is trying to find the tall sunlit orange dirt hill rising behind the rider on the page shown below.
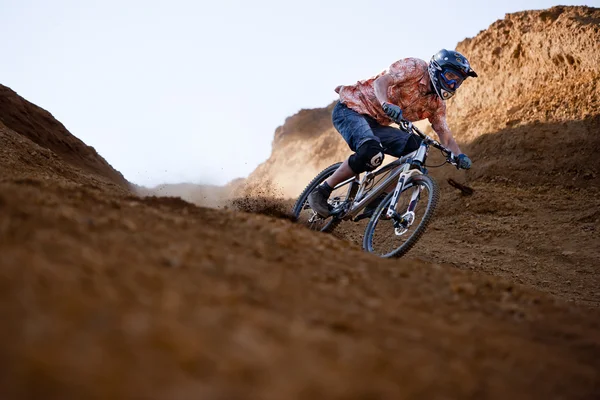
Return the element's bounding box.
[249,7,600,197]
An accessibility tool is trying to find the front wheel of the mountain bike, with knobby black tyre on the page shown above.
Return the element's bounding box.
[363,175,440,258]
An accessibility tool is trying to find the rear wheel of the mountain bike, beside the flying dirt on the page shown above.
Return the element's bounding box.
[292,163,349,232]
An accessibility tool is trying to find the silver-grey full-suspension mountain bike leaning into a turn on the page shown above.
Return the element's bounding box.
[292,120,458,258]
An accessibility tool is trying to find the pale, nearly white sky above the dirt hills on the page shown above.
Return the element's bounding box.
[0,0,600,186]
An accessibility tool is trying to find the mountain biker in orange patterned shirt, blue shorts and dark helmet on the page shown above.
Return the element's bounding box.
[308,49,477,218]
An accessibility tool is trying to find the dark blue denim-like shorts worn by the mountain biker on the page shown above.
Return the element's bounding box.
[331,101,421,157]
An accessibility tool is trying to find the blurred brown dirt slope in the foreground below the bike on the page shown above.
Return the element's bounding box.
[0,179,600,399]
